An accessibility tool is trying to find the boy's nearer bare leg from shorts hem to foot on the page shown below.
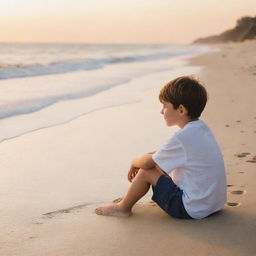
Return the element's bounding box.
[95,167,163,216]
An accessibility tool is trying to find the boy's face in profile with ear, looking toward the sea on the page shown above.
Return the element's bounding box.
[161,101,183,126]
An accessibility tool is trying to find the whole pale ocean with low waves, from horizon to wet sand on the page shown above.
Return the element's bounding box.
[0,43,213,142]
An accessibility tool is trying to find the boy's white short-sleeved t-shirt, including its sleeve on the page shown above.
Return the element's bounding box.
[152,120,227,219]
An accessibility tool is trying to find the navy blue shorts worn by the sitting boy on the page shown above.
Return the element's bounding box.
[152,173,192,219]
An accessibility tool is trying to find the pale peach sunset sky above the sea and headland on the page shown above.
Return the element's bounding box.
[0,0,256,44]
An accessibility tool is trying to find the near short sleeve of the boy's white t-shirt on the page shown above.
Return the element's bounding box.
[152,137,186,173]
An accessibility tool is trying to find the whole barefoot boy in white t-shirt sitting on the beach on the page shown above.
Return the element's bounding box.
[95,76,226,219]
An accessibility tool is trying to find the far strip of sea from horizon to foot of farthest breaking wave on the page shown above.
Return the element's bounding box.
[0,44,212,79]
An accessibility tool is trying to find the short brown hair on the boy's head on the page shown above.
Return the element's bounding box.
[159,76,207,119]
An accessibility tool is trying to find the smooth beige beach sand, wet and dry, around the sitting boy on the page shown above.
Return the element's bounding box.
[0,41,256,256]
